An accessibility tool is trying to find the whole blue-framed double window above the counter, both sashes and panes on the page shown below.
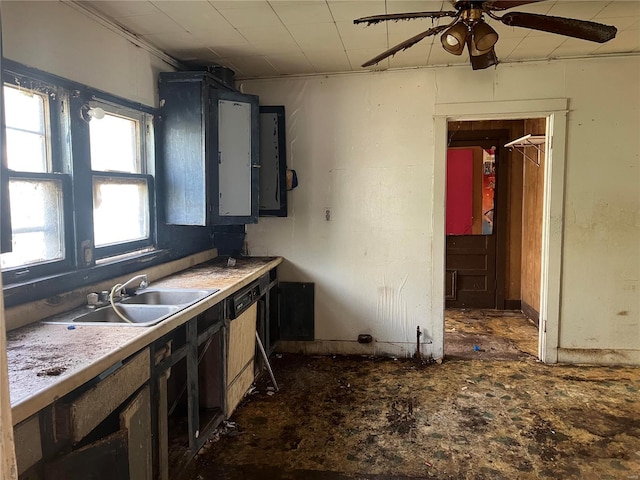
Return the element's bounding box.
[0,66,156,284]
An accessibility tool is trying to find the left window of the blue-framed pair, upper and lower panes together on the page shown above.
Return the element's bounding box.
[0,80,68,269]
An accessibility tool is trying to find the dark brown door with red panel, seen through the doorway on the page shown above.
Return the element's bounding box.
[445,127,510,310]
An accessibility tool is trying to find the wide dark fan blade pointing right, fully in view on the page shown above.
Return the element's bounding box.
[500,12,618,43]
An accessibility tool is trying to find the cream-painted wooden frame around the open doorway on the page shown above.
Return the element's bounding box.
[430,98,569,363]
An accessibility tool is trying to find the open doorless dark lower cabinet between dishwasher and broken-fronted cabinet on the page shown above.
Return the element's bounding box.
[152,303,227,480]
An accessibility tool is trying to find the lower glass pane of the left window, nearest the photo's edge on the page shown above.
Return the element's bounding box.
[0,180,64,268]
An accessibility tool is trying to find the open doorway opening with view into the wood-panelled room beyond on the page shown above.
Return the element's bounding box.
[444,118,546,359]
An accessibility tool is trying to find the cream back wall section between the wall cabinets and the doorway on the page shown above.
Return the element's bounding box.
[243,71,436,355]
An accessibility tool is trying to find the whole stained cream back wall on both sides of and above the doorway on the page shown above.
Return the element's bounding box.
[241,57,640,363]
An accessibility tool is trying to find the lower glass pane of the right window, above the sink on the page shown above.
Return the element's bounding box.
[93,178,149,247]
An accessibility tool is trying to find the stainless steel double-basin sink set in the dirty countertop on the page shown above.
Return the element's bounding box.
[43,288,218,327]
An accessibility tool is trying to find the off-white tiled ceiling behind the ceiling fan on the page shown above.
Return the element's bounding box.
[73,0,640,78]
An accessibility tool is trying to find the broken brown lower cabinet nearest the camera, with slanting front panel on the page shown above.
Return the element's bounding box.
[14,348,153,480]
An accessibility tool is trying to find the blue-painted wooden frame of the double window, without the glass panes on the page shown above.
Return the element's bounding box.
[0,59,159,290]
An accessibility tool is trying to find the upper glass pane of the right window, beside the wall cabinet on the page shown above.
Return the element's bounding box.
[89,113,142,173]
